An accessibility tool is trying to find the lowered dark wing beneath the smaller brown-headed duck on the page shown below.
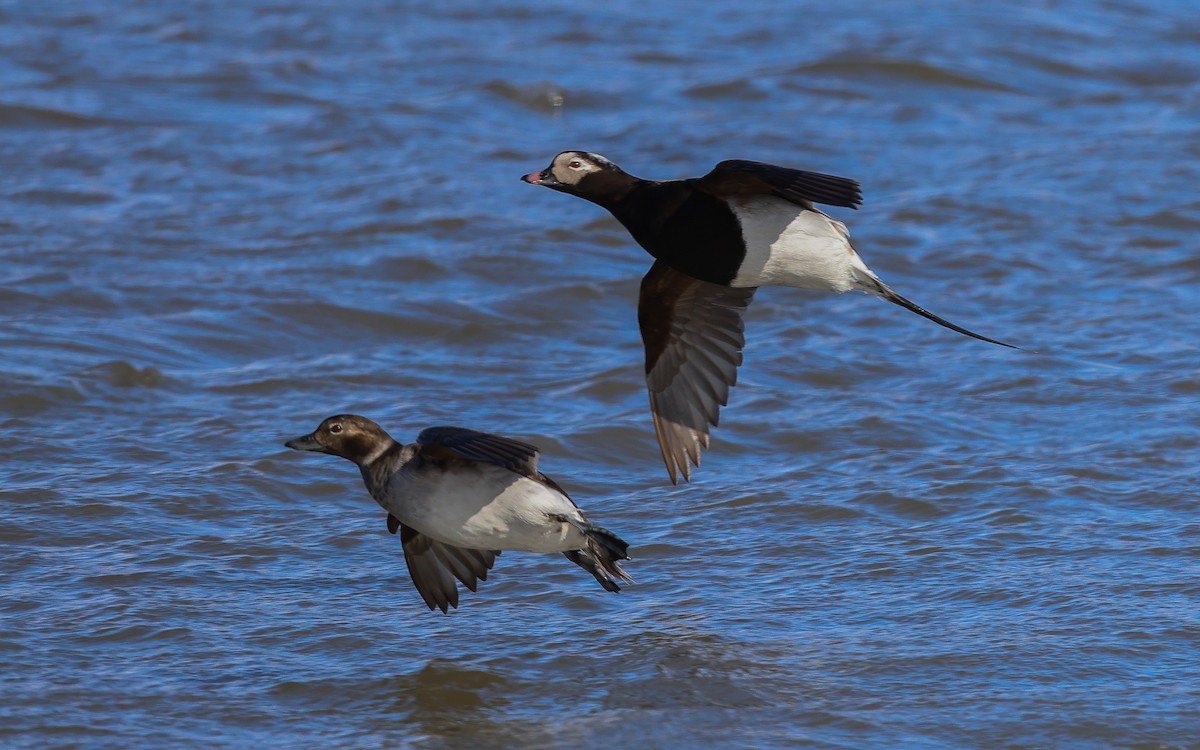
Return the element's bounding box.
[400,524,500,612]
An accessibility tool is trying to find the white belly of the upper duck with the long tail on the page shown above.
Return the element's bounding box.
[731,197,874,292]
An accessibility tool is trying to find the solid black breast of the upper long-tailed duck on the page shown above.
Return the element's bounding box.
[612,180,746,286]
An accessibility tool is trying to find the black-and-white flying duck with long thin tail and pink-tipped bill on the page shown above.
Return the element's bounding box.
[521,151,1016,484]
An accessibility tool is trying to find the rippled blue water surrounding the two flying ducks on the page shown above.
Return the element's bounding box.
[0,0,1200,750]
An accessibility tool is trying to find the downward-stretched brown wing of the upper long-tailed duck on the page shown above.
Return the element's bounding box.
[637,262,755,484]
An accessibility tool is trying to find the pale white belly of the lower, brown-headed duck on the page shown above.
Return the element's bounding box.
[386,464,587,552]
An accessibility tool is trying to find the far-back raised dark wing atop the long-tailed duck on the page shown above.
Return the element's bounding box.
[696,158,863,209]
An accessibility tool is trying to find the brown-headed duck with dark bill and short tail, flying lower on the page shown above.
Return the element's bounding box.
[284,414,630,612]
